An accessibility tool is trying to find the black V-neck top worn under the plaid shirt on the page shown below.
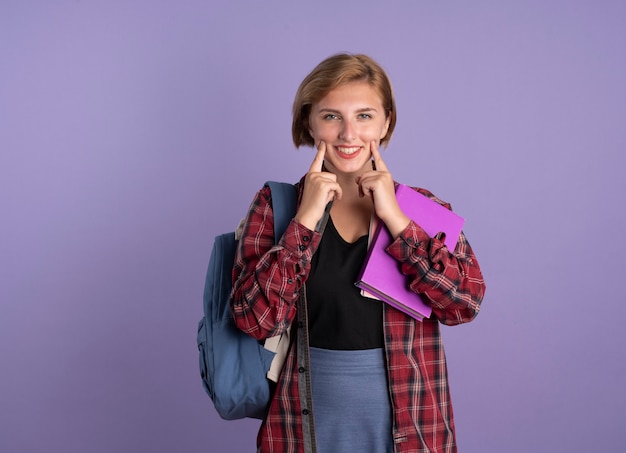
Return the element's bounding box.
[306,217,384,350]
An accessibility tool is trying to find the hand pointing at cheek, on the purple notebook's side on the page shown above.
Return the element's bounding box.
[356,141,410,238]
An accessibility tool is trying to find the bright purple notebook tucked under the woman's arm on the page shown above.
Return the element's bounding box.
[355,184,464,321]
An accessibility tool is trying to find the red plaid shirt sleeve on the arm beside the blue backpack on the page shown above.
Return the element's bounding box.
[231,187,321,340]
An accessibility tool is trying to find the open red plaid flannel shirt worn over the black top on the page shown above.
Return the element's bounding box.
[231,179,485,453]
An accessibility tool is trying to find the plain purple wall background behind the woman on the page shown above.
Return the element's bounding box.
[0,0,626,453]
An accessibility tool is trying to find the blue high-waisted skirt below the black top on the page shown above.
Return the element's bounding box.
[310,348,393,453]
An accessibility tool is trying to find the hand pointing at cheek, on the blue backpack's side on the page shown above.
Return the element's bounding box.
[295,141,341,230]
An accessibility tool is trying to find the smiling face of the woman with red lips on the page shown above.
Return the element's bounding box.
[309,82,389,174]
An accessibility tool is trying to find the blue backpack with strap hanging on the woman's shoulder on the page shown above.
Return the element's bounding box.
[198,181,297,420]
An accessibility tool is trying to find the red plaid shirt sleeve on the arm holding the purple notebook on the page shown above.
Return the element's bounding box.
[387,189,485,325]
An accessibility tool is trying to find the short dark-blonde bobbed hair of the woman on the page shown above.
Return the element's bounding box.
[291,53,396,148]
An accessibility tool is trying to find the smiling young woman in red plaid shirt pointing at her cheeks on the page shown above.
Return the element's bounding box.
[231,54,485,453]
